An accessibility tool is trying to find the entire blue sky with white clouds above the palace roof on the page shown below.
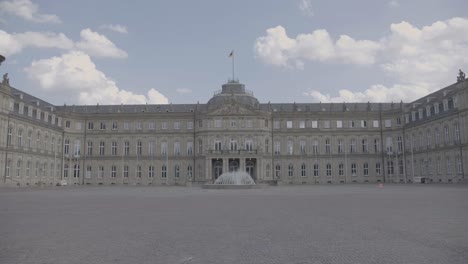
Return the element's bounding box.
[0,0,468,105]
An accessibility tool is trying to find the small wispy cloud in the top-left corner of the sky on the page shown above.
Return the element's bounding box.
[0,0,61,23]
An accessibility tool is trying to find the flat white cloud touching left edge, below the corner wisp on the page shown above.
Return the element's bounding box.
[0,30,74,56]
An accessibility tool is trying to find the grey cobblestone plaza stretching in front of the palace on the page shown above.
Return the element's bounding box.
[0,184,468,264]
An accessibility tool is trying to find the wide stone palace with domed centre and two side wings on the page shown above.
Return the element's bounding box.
[0,74,468,186]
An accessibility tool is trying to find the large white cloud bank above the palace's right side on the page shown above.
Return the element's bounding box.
[255,17,468,102]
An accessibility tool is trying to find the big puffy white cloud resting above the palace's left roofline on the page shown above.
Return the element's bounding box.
[25,51,168,105]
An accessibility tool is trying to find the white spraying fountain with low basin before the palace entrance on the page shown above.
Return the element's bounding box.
[203,171,259,189]
